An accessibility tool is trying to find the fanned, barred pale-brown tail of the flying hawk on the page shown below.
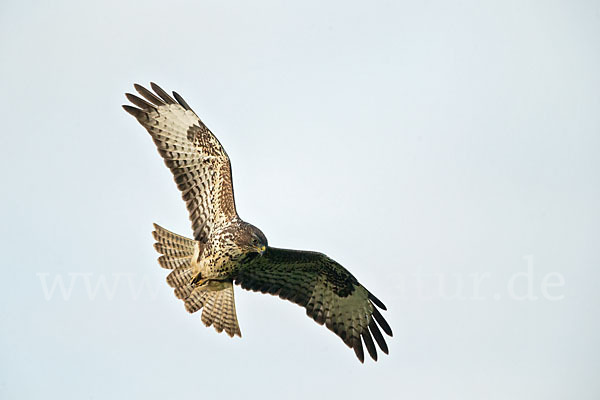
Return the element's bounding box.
[152,224,242,337]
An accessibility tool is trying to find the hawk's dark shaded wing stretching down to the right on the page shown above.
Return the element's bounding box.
[234,247,392,362]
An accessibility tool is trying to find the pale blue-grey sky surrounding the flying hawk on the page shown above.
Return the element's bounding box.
[0,0,600,400]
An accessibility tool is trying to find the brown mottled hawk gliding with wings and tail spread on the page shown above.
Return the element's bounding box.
[123,83,392,363]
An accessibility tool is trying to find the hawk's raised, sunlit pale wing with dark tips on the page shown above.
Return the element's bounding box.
[123,83,237,242]
